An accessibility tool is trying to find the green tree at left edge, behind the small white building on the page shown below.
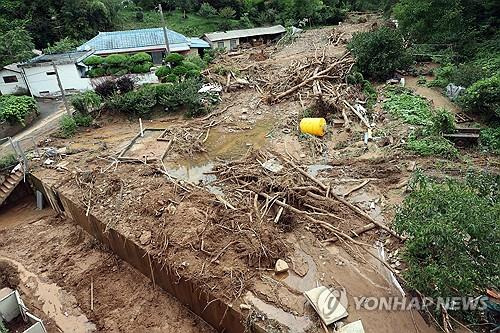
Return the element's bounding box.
[0,28,35,66]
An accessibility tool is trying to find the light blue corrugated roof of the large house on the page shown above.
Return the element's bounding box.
[78,28,209,53]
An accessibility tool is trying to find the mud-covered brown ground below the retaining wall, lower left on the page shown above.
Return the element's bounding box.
[0,198,213,333]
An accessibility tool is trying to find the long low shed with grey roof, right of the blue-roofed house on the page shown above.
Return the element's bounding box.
[203,25,286,50]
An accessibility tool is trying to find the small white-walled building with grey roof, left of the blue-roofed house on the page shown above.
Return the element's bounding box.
[19,51,92,97]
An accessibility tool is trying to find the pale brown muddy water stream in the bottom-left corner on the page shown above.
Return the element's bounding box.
[0,256,96,333]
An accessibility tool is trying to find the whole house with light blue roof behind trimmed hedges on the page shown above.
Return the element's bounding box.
[77,28,210,64]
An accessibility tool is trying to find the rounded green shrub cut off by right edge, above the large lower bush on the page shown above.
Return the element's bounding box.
[458,74,500,118]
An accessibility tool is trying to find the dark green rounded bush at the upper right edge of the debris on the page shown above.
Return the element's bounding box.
[348,27,411,80]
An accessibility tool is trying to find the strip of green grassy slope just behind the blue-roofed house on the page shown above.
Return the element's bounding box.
[117,10,238,37]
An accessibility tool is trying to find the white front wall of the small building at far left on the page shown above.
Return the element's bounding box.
[25,64,92,97]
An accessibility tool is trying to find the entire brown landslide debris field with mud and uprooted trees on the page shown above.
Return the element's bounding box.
[0,14,499,332]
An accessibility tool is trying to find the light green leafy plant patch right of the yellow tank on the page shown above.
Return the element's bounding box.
[383,87,432,125]
